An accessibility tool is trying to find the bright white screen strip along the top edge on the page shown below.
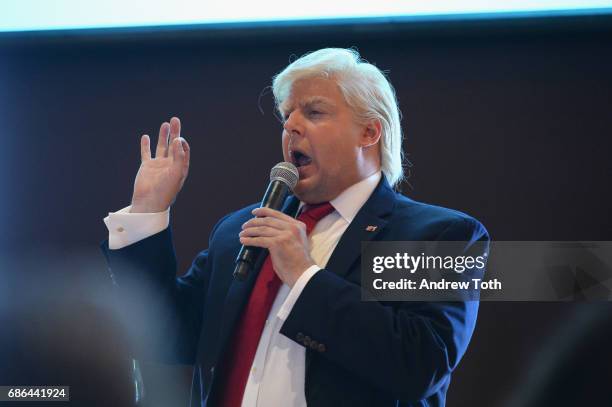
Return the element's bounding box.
[0,0,612,32]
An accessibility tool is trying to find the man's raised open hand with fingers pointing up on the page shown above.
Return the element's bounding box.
[130,117,190,213]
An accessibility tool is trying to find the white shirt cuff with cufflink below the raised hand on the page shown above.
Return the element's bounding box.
[104,205,170,250]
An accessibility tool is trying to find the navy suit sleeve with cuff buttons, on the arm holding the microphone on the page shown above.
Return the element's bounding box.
[281,218,489,401]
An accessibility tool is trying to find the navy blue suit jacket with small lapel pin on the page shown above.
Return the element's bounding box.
[103,177,489,407]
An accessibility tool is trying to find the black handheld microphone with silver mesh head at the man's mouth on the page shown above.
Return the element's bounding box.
[234,162,300,281]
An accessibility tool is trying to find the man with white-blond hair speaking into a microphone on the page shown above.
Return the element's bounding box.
[103,49,488,407]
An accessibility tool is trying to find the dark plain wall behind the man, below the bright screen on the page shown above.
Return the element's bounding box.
[0,17,612,406]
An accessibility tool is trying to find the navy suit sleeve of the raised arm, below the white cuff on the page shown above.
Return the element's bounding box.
[101,215,230,364]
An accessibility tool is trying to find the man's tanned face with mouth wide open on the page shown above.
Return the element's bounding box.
[280,78,366,204]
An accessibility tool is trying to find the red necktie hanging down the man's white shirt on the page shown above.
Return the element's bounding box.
[219,202,334,407]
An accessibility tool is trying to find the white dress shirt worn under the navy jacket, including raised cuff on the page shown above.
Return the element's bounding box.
[104,172,381,407]
